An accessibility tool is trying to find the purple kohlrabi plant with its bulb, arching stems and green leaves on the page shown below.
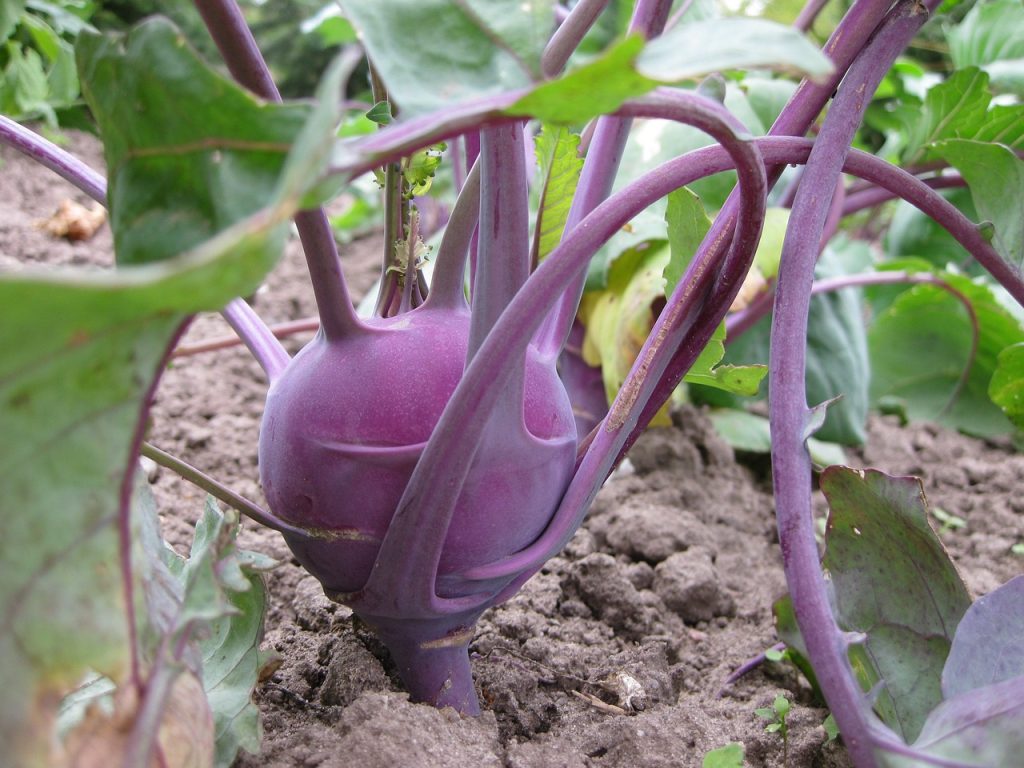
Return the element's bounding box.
[6,0,1024,768]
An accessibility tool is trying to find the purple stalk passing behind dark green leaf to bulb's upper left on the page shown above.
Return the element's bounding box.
[196,0,362,339]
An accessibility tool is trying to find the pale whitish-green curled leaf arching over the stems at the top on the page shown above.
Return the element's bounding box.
[637,17,833,83]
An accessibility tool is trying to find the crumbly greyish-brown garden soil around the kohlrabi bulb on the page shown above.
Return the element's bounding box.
[0,131,1024,768]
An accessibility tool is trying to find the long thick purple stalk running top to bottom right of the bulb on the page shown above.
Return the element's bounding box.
[768,0,928,768]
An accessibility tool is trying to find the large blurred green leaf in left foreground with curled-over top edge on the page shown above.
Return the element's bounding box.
[0,25,340,767]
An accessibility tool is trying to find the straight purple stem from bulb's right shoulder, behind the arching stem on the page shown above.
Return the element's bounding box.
[537,0,672,357]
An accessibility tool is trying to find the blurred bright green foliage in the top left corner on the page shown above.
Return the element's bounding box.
[0,0,96,126]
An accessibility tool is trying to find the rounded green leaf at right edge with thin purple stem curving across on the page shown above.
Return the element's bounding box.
[868,273,1024,435]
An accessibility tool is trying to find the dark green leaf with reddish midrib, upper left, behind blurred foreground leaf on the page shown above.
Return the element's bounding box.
[78,18,310,264]
